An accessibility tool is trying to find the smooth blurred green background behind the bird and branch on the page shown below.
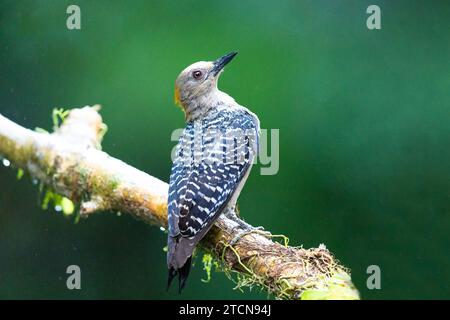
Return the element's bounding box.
[0,0,450,299]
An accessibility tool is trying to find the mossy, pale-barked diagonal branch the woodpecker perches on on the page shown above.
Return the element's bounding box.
[0,106,359,299]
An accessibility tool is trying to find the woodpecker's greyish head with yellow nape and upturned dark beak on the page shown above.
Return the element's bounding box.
[175,52,237,120]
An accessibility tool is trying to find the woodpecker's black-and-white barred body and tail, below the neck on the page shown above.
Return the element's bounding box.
[167,105,259,290]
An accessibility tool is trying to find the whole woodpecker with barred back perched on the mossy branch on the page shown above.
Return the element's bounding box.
[167,52,260,293]
